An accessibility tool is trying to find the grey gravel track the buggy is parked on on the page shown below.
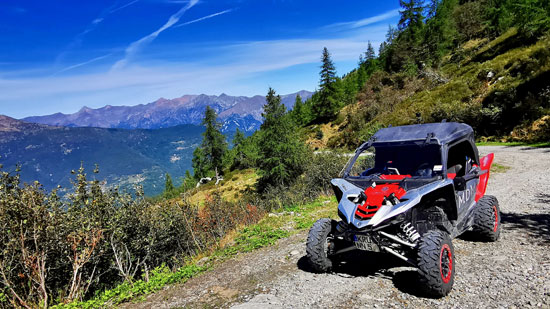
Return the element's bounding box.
[125,146,550,309]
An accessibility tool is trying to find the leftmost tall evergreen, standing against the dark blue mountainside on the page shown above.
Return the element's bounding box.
[193,106,227,178]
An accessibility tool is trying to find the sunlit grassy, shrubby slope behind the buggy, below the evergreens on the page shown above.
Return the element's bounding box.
[327,28,550,148]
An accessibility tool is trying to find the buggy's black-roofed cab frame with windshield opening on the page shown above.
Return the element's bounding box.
[340,122,480,187]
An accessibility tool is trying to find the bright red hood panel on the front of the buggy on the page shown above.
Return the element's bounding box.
[355,183,411,219]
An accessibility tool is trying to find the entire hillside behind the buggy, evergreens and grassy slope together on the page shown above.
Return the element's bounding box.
[294,0,550,148]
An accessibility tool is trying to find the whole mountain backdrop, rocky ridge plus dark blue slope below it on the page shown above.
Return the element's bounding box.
[0,91,312,195]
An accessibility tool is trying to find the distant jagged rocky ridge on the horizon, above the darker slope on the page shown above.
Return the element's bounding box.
[22,90,313,133]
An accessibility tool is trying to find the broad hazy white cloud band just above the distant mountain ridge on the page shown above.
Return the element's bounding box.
[0,10,396,117]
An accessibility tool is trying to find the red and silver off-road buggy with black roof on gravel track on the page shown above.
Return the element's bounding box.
[306,122,501,297]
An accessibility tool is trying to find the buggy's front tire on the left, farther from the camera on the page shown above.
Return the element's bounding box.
[306,218,336,272]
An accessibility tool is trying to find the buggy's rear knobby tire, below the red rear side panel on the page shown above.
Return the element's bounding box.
[473,195,501,241]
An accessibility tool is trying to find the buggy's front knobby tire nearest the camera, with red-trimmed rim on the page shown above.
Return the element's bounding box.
[417,230,455,297]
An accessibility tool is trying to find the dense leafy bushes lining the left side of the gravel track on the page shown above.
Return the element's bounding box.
[0,162,264,308]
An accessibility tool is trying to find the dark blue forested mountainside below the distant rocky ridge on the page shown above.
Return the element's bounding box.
[0,115,204,195]
